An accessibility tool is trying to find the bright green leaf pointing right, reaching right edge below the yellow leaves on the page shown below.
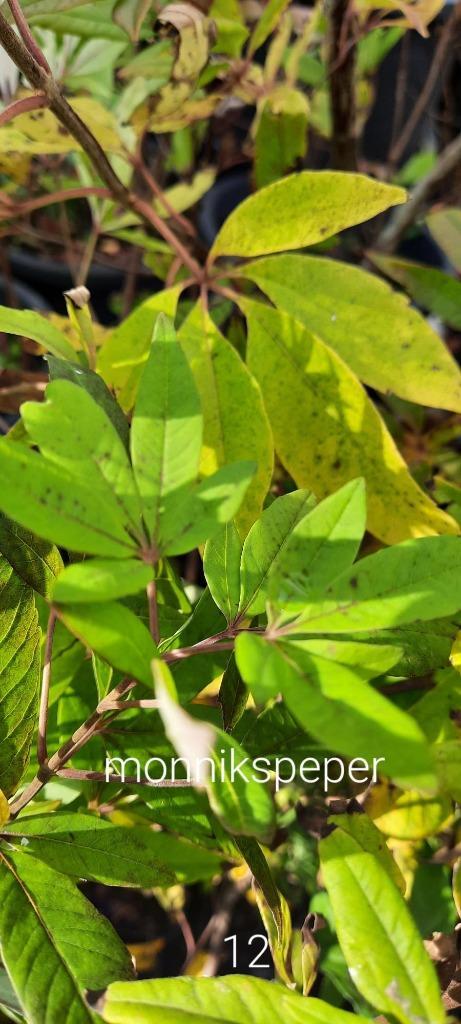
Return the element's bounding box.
[292,537,461,633]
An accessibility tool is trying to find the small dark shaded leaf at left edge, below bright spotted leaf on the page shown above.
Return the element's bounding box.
[0,513,64,600]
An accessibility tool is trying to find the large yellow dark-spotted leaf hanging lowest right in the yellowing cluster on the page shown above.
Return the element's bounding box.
[240,299,458,544]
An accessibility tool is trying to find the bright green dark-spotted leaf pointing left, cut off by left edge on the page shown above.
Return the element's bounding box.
[0,438,136,558]
